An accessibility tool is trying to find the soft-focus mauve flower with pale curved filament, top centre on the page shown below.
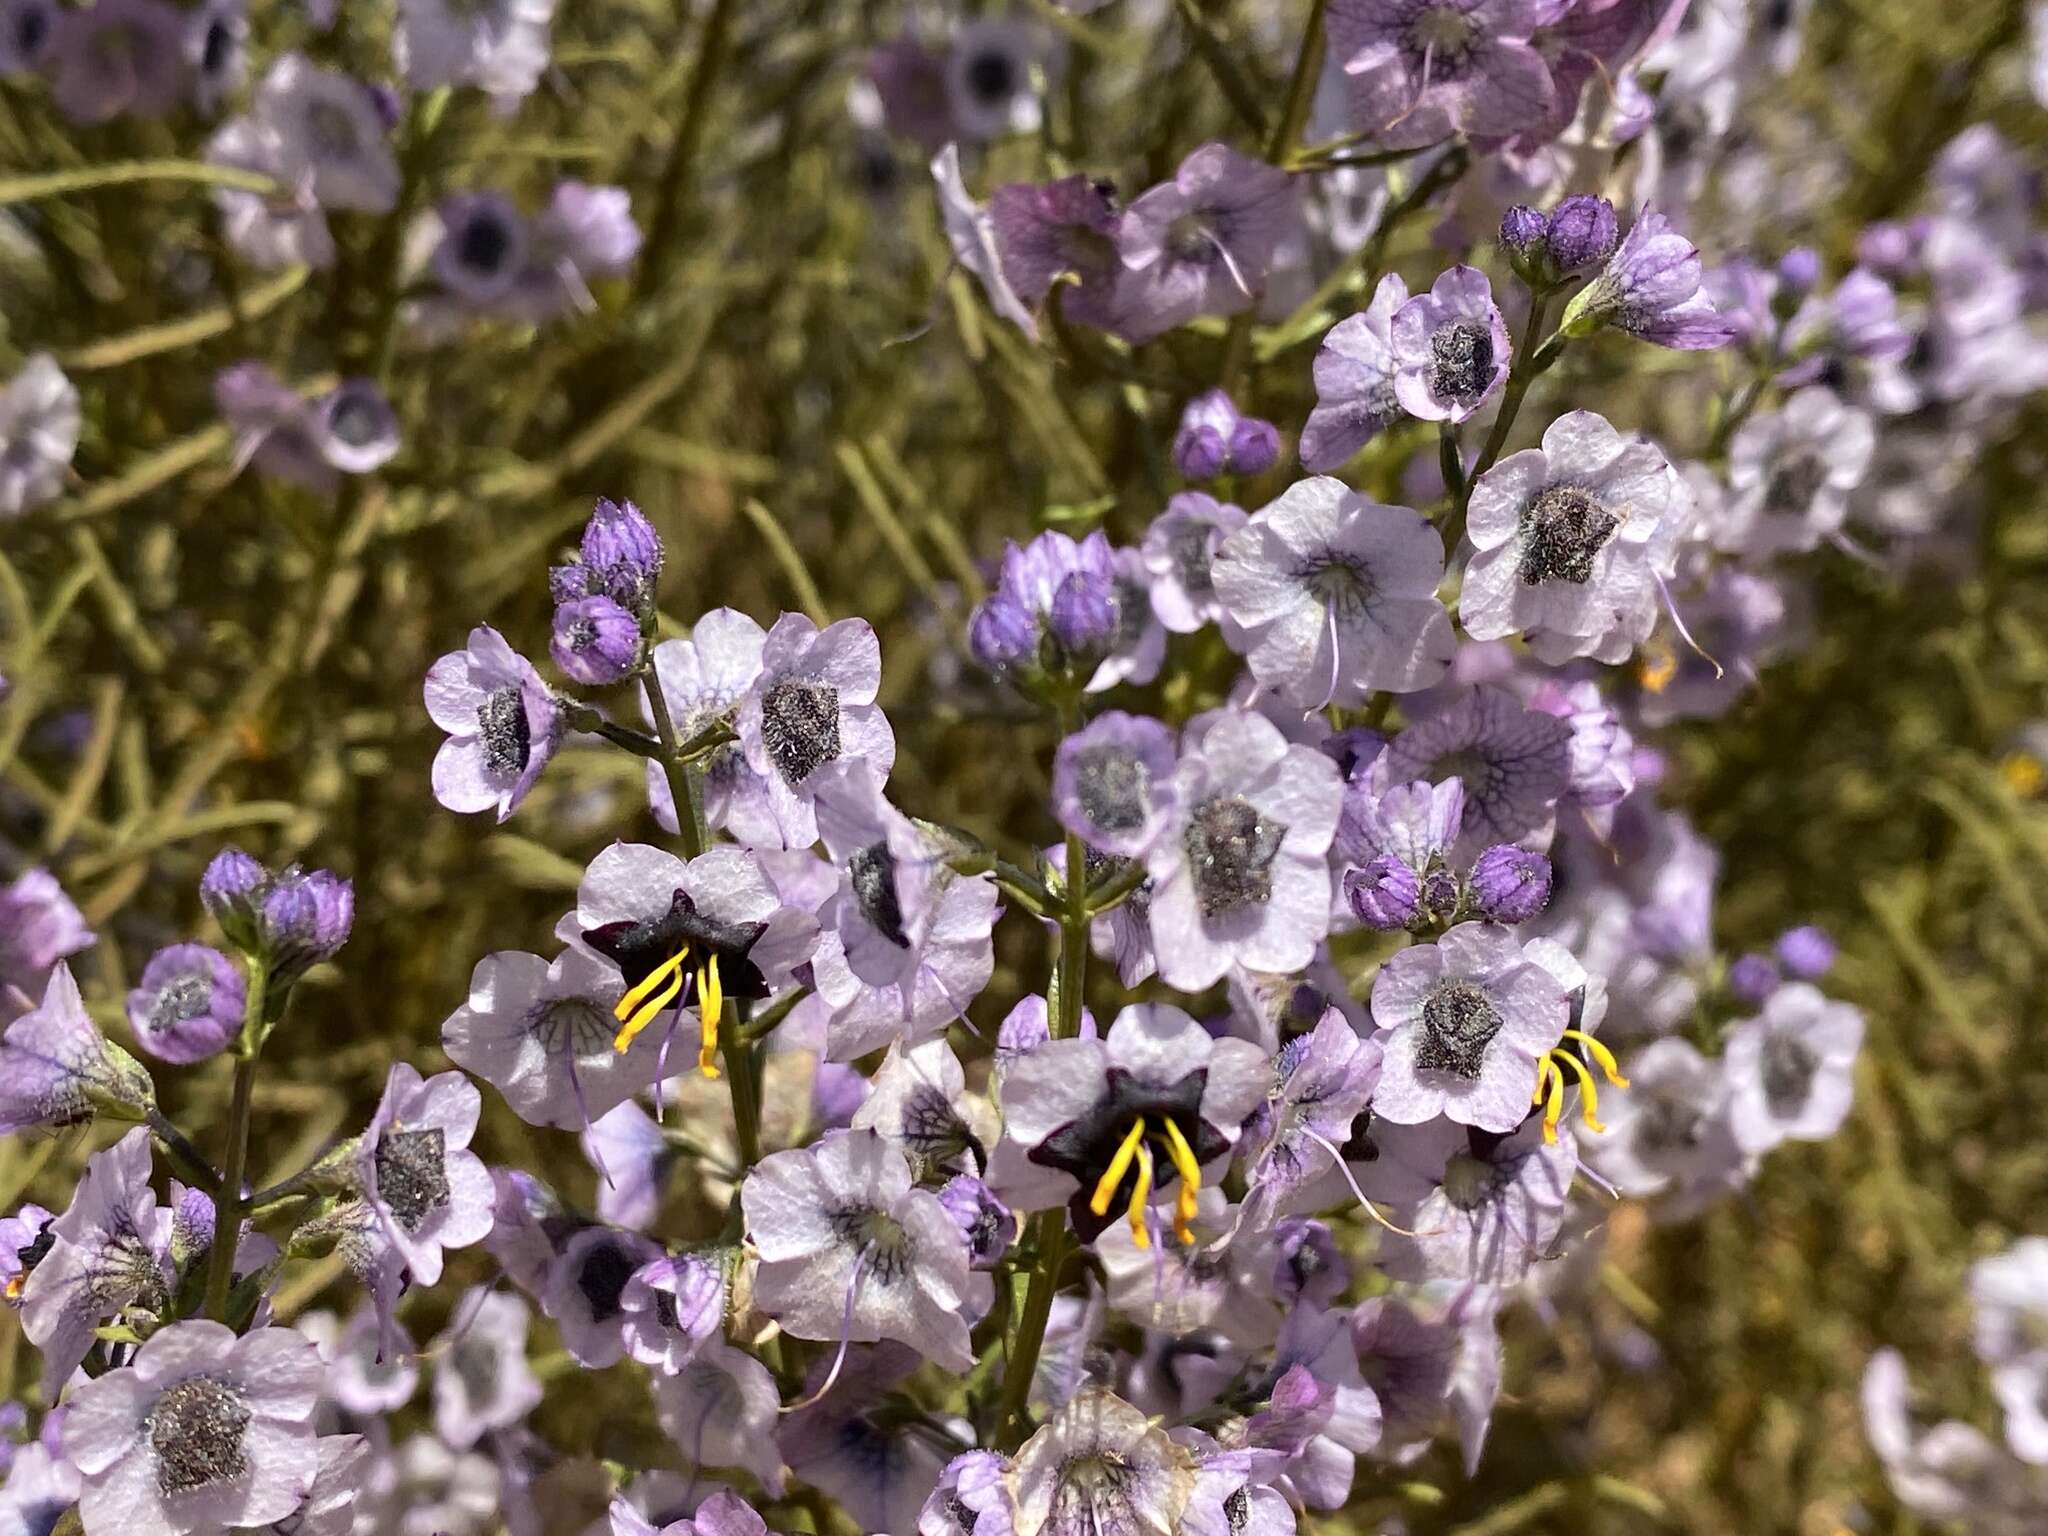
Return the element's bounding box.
[1114,143,1298,342]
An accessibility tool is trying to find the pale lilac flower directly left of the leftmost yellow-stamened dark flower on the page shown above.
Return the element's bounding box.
[440,946,657,1128]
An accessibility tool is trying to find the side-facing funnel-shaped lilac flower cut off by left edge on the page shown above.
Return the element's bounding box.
[0,961,156,1133]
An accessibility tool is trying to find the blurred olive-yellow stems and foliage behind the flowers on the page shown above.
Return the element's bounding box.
[0,0,2048,1536]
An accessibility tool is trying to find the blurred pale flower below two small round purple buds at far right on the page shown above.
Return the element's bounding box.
[1722,981,1864,1153]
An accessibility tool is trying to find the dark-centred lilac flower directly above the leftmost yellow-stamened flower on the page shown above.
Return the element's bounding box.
[737,612,895,848]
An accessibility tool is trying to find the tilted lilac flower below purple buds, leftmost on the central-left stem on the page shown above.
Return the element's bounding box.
[426,625,565,821]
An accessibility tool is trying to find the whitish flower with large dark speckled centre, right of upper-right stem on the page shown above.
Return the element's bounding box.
[1458,412,1692,666]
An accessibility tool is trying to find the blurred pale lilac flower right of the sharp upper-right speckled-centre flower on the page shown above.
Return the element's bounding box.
[1714,387,1878,561]
